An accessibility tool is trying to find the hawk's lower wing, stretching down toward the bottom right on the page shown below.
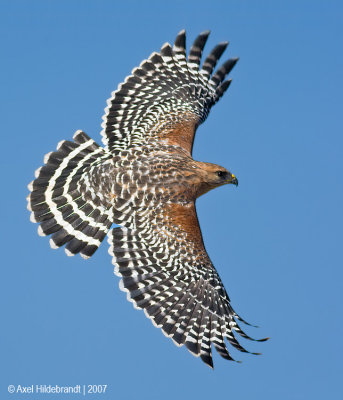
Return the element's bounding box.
[109,203,264,367]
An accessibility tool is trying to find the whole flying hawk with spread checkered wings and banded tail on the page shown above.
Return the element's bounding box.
[28,30,266,367]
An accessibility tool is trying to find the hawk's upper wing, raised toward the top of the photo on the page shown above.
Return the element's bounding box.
[101,31,237,153]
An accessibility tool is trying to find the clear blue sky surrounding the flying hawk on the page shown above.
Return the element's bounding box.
[0,0,343,400]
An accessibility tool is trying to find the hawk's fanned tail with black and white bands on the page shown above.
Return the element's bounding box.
[27,131,112,258]
